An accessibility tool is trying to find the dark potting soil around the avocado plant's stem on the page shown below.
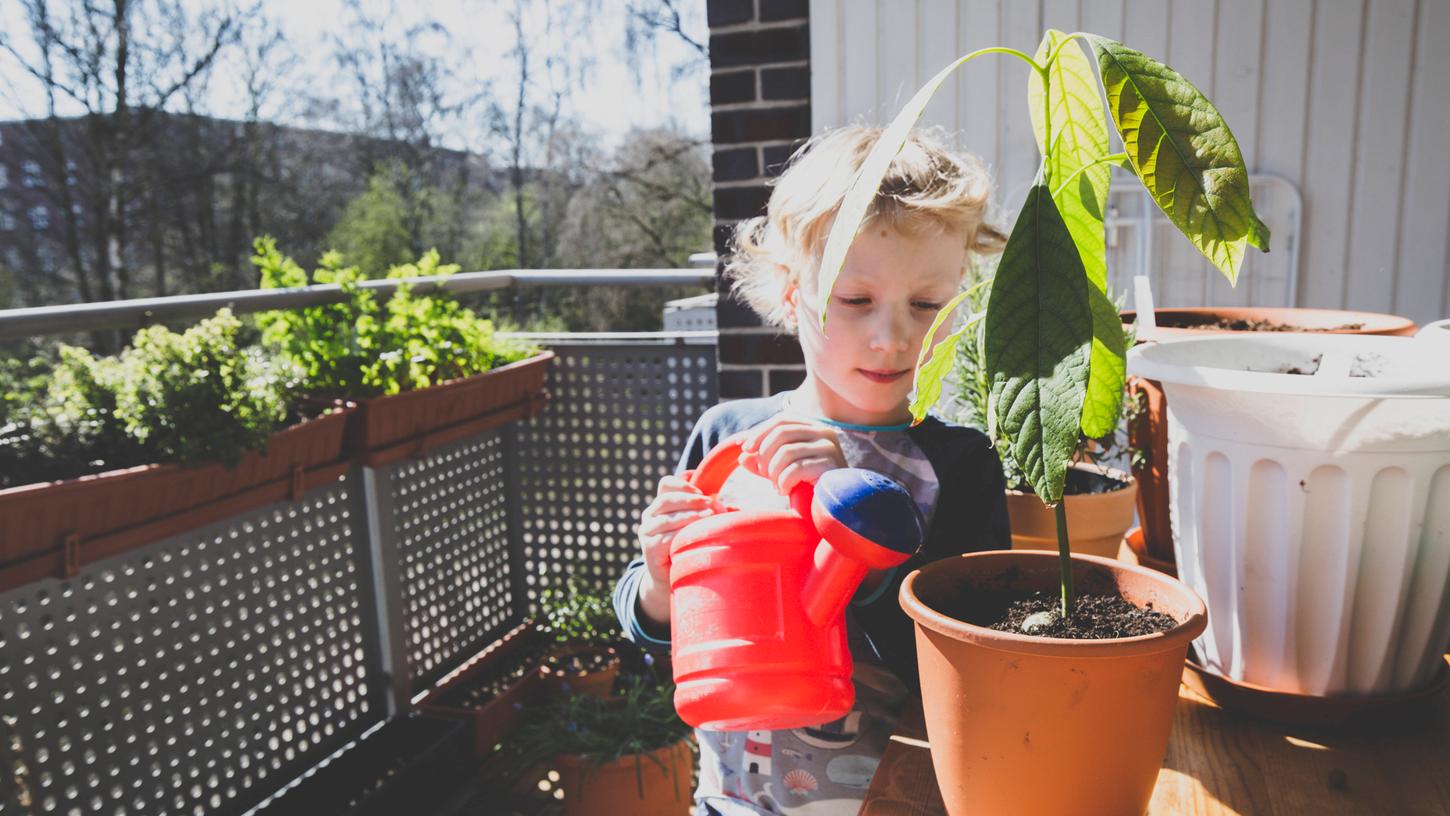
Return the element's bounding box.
[960,591,1177,641]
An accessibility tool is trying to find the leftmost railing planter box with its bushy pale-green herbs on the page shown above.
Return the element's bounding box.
[0,309,349,590]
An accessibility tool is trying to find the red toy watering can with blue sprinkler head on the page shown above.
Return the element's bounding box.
[670,436,925,730]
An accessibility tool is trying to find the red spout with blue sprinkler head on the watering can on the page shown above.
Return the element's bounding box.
[792,468,927,626]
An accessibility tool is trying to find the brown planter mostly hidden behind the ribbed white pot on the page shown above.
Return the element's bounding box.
[1122,306,1415,565]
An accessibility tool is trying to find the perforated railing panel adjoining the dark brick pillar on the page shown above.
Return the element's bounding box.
[518,342,718,604]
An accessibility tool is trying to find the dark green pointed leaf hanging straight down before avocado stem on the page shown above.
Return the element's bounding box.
[985,178,1093,504]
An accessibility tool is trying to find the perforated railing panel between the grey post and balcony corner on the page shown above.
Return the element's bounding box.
[389,429,521,691]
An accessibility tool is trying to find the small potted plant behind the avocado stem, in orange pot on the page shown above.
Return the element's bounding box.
[954,270,1138,558]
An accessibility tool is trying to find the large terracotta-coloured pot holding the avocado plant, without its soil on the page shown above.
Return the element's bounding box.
[900,551,1206,816]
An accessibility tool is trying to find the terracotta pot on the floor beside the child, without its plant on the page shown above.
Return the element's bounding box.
[555,739,695,816]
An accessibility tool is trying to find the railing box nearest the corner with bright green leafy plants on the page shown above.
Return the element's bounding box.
[252,238,554,467]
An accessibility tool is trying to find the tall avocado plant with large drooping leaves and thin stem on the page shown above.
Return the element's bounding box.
[819,30,1269,626]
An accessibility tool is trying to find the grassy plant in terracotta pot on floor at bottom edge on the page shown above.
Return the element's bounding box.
[486,673,695,816]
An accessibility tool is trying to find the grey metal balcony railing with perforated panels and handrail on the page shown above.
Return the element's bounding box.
[0,271,716,816]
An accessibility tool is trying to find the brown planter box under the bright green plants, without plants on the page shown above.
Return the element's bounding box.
[347,351,554,467]
